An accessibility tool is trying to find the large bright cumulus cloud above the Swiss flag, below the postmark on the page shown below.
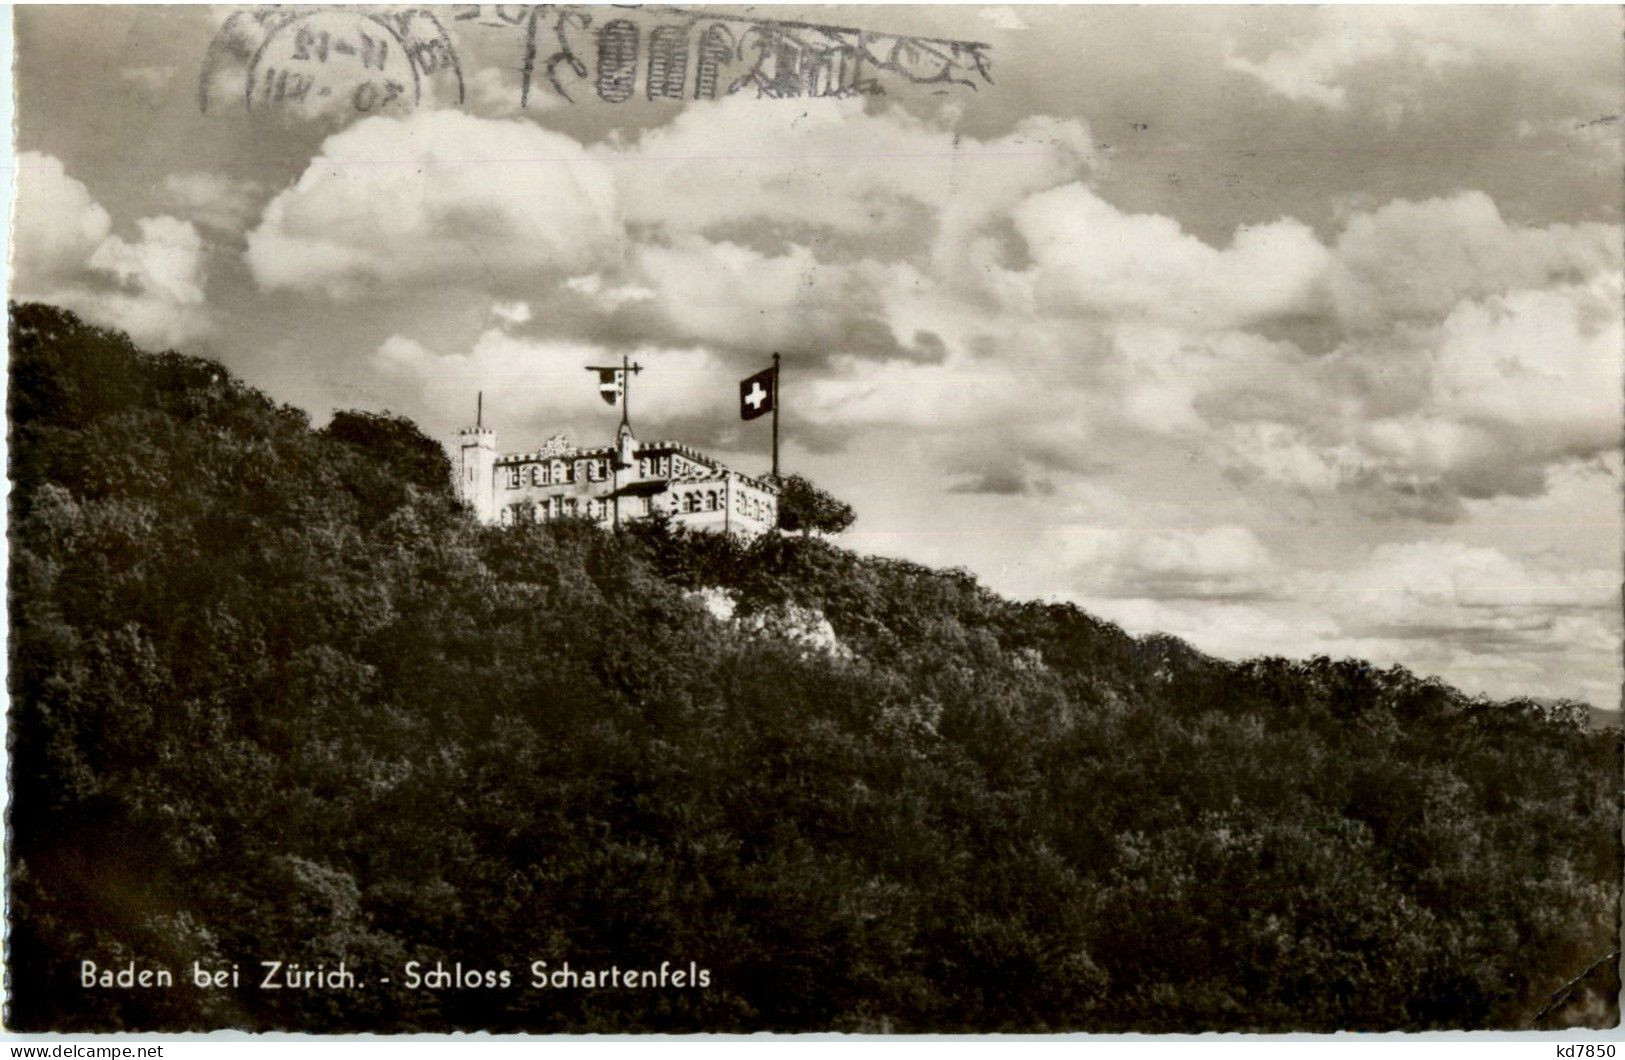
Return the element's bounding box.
[481,98,1092,364]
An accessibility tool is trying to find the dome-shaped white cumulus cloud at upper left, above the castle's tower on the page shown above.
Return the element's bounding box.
[247,111,621,298]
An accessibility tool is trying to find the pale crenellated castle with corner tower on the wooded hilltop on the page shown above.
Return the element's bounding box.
[453,418,778,537]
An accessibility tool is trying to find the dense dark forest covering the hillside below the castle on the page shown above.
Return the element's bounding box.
[8,306,1620,1031]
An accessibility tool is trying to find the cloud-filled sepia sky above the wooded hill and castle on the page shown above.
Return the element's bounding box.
[13,7,1625,707]
